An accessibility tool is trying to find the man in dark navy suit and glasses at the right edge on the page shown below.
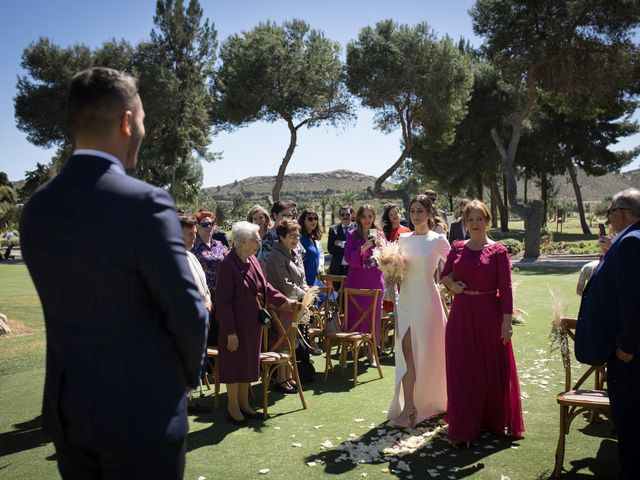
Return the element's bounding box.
[576,189,640,480]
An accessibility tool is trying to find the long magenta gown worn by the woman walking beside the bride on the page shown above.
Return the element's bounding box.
[442,241,524,442]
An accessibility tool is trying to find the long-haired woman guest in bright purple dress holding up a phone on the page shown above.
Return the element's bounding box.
[344,205,384,367]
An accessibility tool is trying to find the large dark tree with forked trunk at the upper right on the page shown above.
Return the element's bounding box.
[470,0,640,257]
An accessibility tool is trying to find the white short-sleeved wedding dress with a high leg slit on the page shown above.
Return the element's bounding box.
[387,231,451,424]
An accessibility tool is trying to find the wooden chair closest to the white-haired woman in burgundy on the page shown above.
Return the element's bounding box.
[260,304,307,419]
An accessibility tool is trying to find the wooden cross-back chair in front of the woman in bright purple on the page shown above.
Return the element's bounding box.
[324,288,383,385]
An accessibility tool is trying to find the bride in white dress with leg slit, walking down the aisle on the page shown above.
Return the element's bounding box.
[388,195,451,428]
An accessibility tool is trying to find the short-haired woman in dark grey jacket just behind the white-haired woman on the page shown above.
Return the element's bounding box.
[265,220,309,393]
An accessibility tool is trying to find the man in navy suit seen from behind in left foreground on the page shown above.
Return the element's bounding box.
[20,68,207,479]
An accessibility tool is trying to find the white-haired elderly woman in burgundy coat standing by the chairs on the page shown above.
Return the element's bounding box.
[215,222,295,425]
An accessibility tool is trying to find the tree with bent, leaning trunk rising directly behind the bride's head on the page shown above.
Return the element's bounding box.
[347,20,473,203]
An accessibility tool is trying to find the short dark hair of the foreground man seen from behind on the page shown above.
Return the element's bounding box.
[67,67,138,135]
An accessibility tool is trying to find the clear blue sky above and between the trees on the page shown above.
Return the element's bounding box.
[0,0,640,187]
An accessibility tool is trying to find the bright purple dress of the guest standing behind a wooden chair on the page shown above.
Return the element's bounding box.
[344,230,384,338]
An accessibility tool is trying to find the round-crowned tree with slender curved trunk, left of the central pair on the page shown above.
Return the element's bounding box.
[216,20,353,200]
